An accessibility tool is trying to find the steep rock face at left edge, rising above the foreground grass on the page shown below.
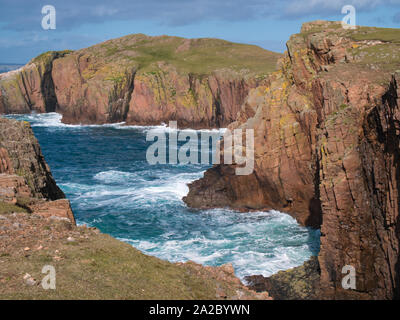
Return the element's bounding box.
[0,119,75,223]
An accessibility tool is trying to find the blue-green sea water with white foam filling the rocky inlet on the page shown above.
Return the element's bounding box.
[7,113,320,279]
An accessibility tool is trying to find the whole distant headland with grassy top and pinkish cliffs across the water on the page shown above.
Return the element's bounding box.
[0,34,280,128]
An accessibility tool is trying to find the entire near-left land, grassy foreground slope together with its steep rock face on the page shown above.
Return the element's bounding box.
[0,119,270,299]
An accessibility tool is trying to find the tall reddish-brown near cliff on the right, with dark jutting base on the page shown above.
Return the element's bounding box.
[184,21,400,299]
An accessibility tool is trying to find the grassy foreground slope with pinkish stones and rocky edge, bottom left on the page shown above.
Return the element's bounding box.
[0,207,268,299]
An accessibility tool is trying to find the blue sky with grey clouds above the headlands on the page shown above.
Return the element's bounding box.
[0,0,400,64]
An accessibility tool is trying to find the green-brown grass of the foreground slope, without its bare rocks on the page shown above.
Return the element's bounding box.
[0,231,244,299]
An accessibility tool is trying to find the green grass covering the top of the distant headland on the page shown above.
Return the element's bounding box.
[77,34,281,76]
